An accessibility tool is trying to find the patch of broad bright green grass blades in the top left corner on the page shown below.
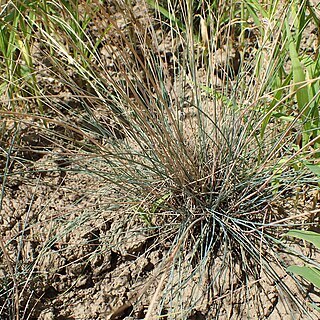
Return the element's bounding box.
[0,1,41,110]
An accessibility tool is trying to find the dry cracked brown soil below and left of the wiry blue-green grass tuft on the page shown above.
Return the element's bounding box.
[0,153,316,320]
